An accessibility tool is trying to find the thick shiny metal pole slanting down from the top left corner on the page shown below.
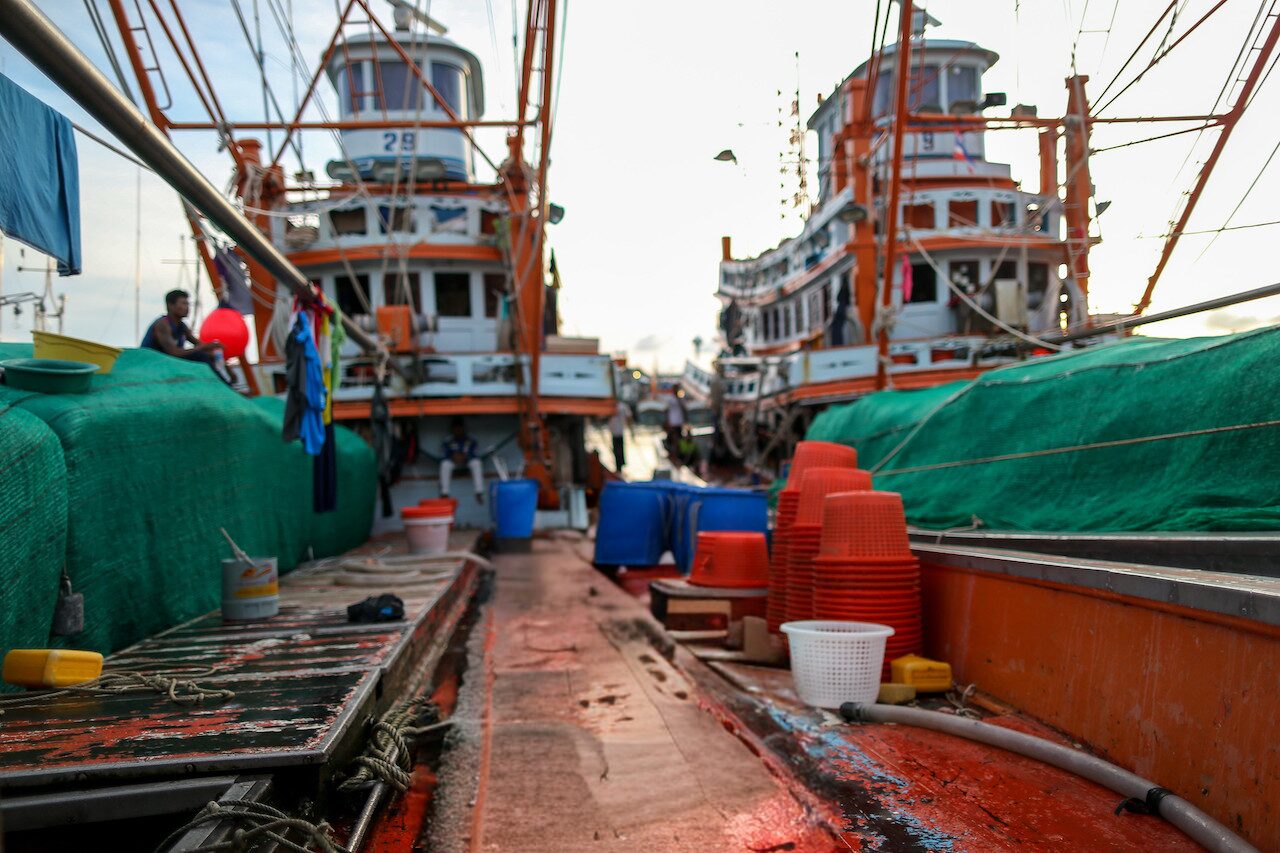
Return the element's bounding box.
[0,0,385,352]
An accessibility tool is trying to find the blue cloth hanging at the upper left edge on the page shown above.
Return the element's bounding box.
[0,74,81,275]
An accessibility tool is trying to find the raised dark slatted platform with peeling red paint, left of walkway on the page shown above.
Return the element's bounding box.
[0,535,475,789]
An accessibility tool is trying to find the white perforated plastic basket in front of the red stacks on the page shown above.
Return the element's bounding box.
[782,620,893,708]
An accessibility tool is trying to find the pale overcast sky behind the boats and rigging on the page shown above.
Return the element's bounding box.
[0,0,1280,370]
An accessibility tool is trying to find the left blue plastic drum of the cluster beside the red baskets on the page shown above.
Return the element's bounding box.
[595,483,673,566]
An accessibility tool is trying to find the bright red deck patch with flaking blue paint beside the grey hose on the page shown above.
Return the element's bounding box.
[699,665,1198,853]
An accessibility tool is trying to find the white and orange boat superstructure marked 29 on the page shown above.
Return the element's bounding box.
[242,15,614,517]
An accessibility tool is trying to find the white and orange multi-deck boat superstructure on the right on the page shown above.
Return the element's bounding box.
[685,18,1097,418]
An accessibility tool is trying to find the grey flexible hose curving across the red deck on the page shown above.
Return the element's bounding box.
[840,702,1258,853]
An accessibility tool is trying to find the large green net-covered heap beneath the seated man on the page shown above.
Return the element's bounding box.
[0,345,376,652]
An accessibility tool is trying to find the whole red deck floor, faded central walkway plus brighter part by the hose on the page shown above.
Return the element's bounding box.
[412,540,1196,853]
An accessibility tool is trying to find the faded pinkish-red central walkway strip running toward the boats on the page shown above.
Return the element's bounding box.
[419,540,835,853]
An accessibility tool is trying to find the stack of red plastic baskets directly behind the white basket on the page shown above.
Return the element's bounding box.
[813,492,923,678]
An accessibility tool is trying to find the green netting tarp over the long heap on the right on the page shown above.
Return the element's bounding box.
[806,328,1280,533]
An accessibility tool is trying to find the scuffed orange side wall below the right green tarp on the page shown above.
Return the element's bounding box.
[923,564,1280,850]
